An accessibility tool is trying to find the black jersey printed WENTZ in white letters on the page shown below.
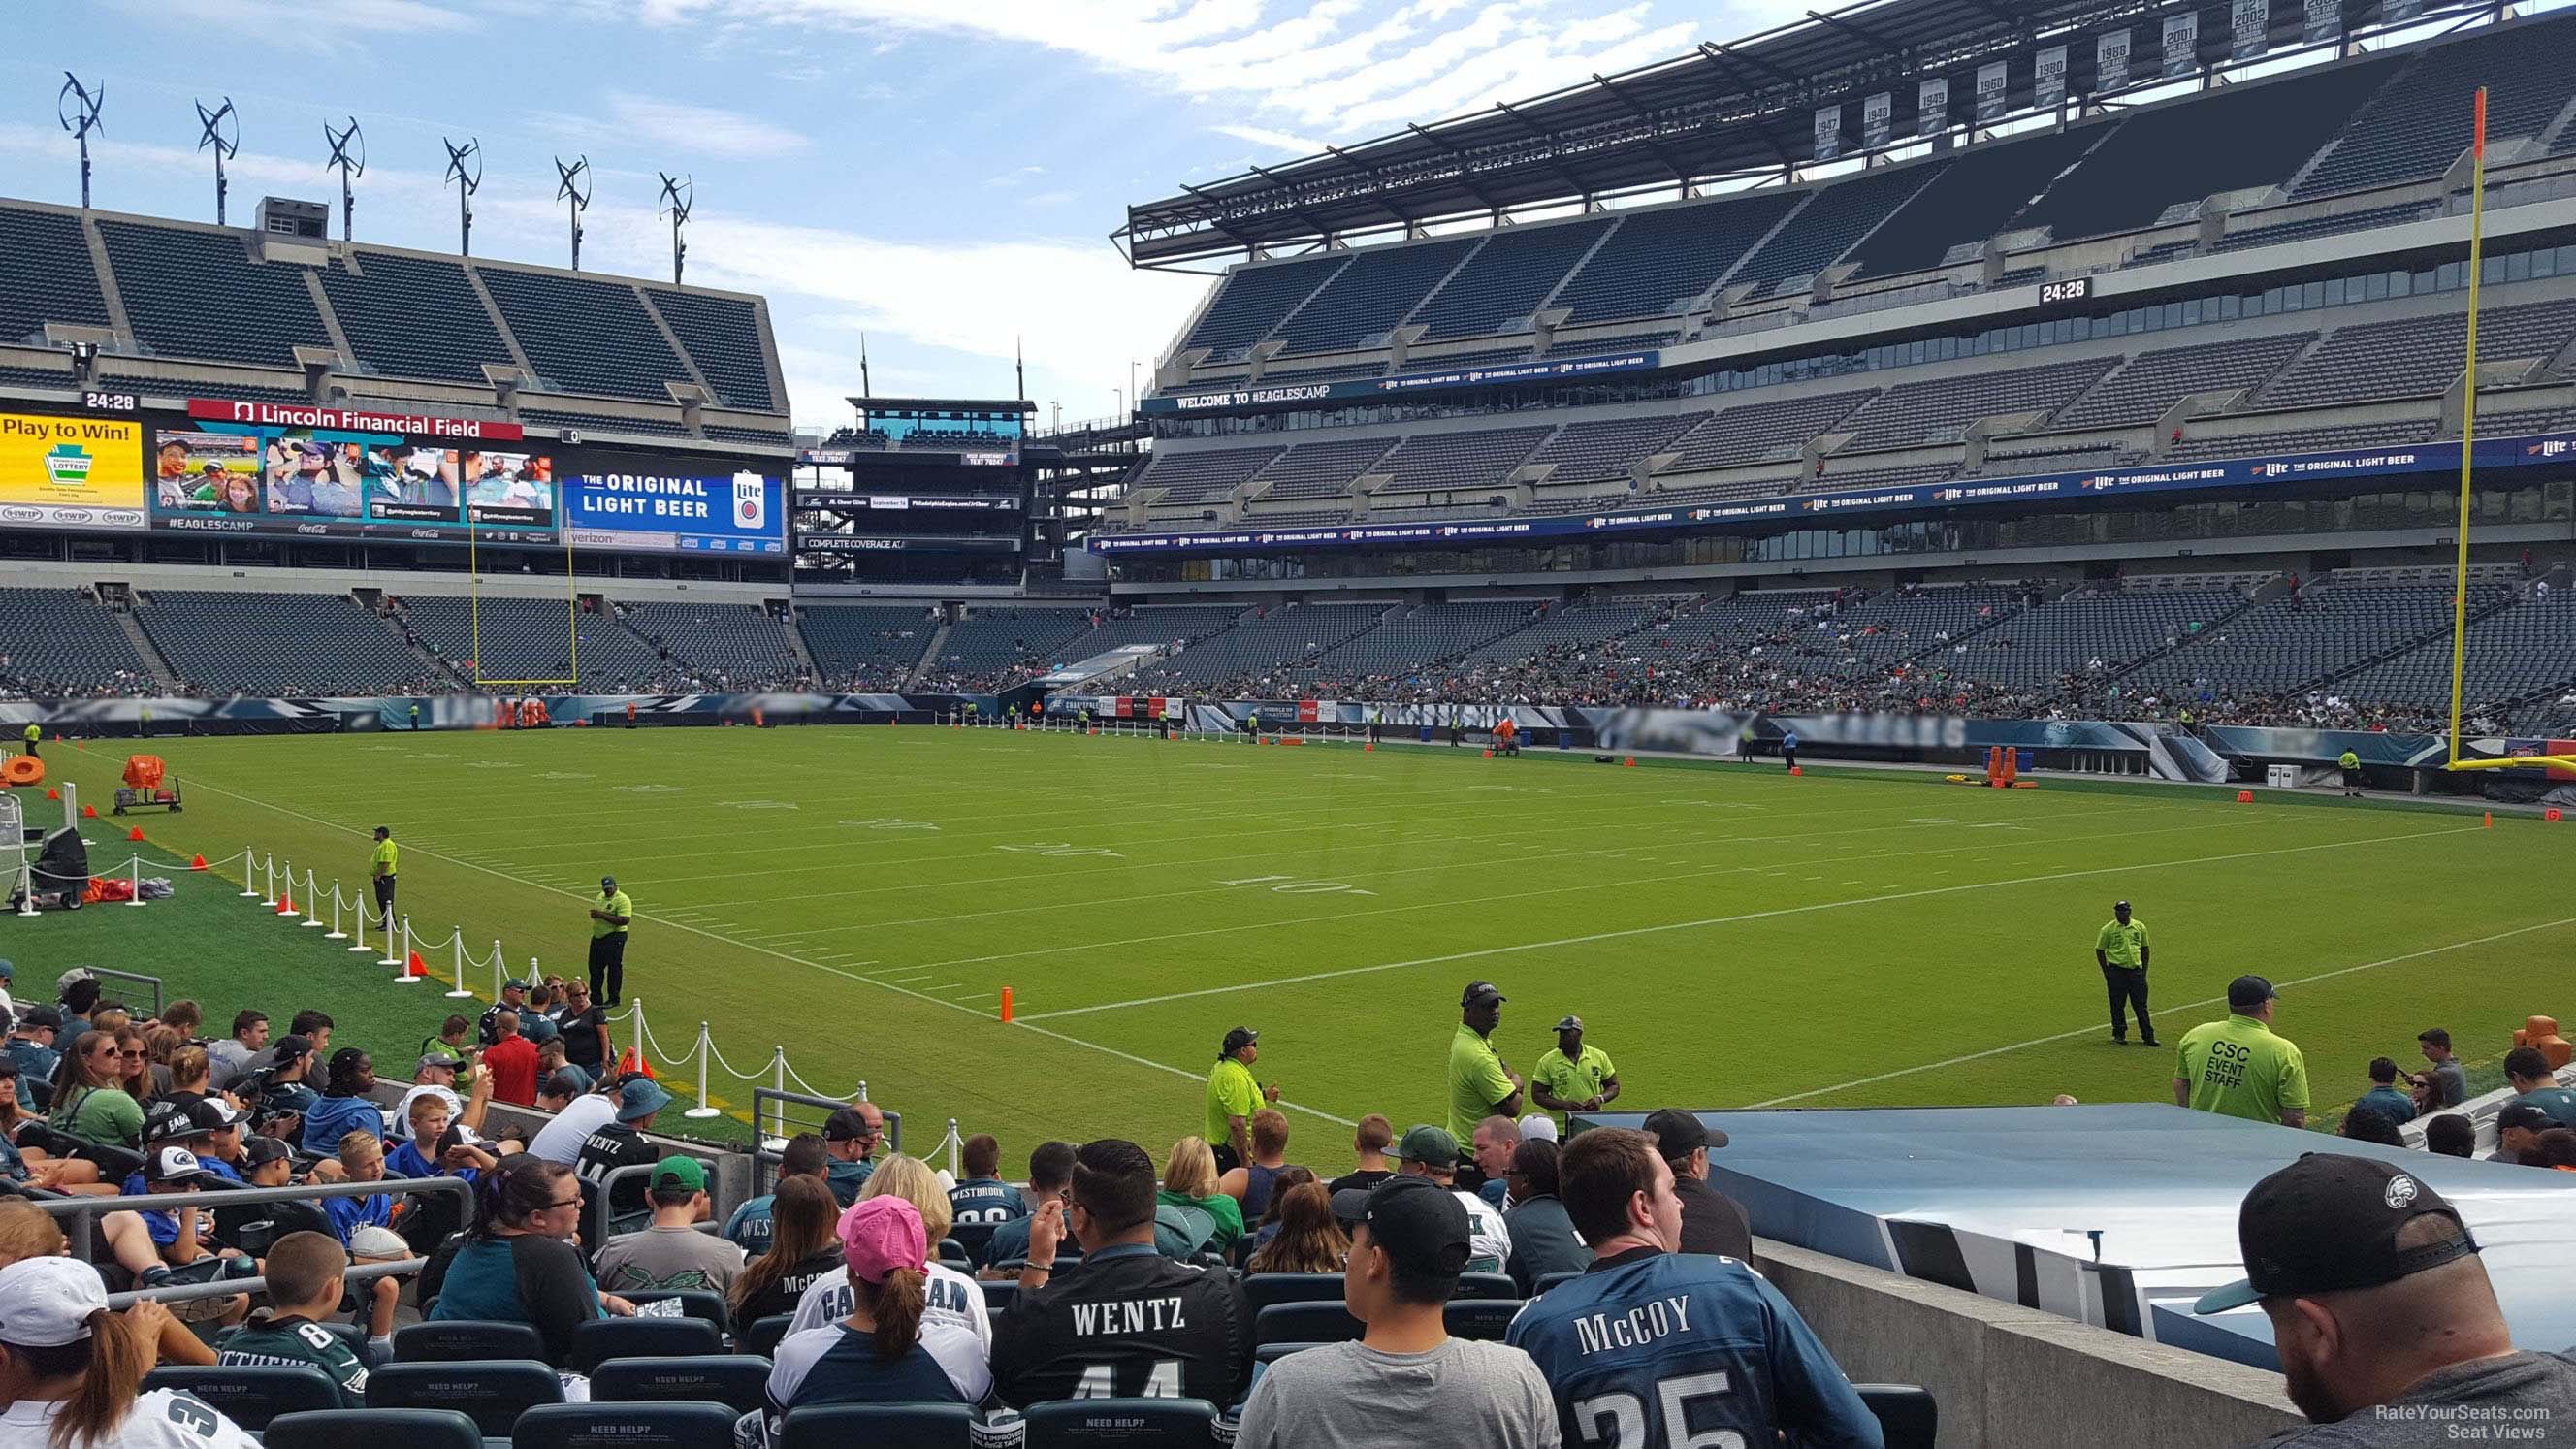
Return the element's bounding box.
[992,1242,1252,1407]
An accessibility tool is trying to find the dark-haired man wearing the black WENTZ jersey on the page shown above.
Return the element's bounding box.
[992,1137,1252,1407]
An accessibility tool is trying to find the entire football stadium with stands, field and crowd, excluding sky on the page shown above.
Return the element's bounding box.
[0,0,2576,1449]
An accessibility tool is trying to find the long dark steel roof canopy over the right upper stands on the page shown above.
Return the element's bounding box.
[1111,0,2494,266]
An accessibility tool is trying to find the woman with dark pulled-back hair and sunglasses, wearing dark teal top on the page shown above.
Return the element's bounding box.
[425,1152,633,1367]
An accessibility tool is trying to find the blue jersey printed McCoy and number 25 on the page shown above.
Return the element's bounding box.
[1504,1250,1884,1449]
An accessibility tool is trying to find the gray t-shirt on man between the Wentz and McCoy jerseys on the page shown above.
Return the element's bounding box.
[1234,1338,1563,1449]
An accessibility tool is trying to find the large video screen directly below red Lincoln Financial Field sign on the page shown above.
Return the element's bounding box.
[152,426,557,544]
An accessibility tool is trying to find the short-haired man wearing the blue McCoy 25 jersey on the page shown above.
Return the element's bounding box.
[1504,1127,1884,1449]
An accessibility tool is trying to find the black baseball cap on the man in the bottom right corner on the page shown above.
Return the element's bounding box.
[2192,1152,2478,1312]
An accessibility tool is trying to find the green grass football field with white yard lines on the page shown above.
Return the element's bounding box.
[0,727,2576,1160]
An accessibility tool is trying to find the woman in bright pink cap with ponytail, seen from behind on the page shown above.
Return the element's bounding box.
[767,1196,992,1436]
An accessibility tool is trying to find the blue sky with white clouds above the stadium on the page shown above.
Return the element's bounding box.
[0,0,1801,426]
